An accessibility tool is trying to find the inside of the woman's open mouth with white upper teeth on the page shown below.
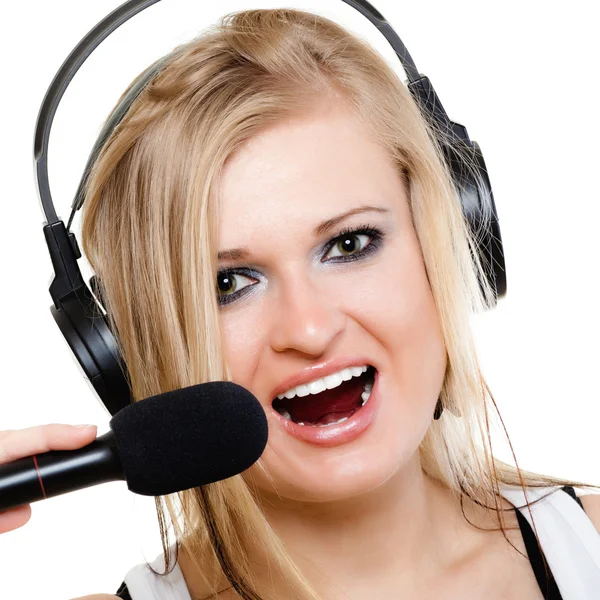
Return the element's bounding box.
[273,366,375,427]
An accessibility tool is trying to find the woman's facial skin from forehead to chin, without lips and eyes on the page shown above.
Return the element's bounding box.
[219,103,446,506]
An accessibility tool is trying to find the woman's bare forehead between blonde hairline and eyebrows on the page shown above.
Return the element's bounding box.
[218,109,404,248]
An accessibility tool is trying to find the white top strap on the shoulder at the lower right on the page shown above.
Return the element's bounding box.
[500,486,600,600]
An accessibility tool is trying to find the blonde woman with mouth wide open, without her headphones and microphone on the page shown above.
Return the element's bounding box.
[2,9,600,600]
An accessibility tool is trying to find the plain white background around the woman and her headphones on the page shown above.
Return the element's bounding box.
[0,0,600,600]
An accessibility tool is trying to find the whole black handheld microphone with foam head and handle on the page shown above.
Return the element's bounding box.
[0,381,268,510]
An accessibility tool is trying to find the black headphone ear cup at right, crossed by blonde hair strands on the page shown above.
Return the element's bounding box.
[442,141,506,304]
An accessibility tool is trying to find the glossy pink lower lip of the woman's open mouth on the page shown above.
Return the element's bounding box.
[271,363,380,448]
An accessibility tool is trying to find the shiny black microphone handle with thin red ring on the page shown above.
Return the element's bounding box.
[0,431,125,510]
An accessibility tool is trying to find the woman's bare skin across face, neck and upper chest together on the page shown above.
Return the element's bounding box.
[74,105,600,600]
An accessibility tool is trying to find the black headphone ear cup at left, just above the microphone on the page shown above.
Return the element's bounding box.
[50,284,131,415]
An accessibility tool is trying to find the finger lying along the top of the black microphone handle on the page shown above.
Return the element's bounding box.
[0,423,97,464]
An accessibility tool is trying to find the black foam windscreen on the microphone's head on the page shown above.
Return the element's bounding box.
[110,381,268,496]
